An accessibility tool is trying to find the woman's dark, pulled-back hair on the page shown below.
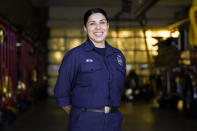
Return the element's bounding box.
[83,8,108,26]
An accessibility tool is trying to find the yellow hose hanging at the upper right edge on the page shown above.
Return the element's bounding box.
[189,0,197,46]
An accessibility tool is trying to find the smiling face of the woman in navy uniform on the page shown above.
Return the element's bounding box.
[84,13,109,46]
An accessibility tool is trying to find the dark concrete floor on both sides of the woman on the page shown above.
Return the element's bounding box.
[5,99,197,131]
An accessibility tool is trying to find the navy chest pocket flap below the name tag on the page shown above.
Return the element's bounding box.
[81,63,103,73]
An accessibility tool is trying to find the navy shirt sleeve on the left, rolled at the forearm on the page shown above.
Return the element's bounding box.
[54,52,77,107]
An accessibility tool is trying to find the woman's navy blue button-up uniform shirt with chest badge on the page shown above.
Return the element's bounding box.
[54,39,126,108]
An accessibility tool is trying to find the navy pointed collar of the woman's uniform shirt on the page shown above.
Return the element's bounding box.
[85,39,118,56]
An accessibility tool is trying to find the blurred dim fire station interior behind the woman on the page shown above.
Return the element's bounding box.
[0,0,197,131]
